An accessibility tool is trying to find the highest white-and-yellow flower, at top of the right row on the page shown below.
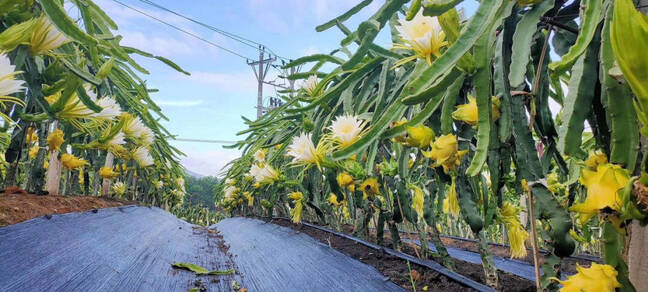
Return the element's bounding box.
[394,11,448,66]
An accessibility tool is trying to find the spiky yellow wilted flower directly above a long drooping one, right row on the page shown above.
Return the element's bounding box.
[423,134,468,173]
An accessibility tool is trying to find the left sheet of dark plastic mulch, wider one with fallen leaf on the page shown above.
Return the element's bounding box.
[0,206,240,291]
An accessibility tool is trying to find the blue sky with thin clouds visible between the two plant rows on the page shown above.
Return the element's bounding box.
[95,0,476,175]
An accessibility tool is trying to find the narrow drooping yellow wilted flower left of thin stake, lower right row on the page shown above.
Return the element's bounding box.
[499,202,529,258]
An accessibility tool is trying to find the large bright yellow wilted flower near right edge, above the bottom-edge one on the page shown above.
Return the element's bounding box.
[569,163,630,223]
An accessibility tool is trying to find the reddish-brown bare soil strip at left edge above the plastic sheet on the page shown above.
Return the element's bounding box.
[0,187,138,226]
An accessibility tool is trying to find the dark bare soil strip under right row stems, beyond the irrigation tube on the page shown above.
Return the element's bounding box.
[264,219,535,291]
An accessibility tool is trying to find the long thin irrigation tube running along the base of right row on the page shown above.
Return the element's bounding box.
[266,217,495,291]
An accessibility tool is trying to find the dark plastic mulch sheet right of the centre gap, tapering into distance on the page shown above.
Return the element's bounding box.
[216,217,403,291]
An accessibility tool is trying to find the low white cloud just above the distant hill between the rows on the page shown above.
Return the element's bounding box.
[174,148,241,176]
